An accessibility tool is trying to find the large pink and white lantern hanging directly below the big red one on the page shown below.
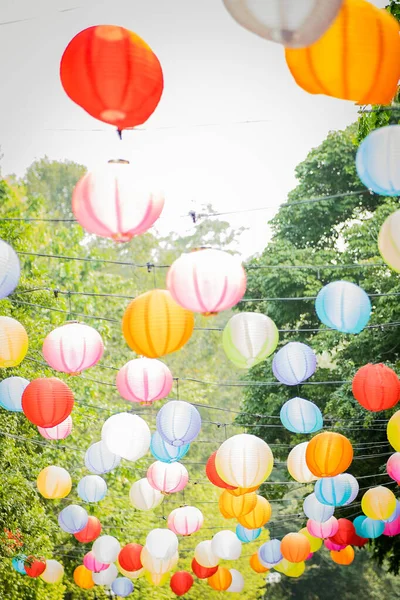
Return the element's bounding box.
[72,161,164,242]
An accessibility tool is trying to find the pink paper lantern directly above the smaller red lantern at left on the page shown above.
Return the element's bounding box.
[42,321,104,375]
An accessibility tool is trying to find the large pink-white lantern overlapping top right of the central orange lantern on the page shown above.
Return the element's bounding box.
[167,249,246,316]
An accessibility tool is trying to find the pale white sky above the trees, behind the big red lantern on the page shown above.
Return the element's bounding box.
[0,0,385,256]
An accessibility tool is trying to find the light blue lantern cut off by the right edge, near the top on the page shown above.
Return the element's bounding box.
[356,125,400,196]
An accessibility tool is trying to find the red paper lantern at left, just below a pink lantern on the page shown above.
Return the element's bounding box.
[22,377,74,428]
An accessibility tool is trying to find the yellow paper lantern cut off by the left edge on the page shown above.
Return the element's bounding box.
[0,317,29,368]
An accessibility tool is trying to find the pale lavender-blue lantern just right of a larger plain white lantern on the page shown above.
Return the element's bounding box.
[156,400,201,447]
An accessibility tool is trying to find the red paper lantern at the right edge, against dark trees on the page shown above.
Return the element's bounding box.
[352,363,400,412]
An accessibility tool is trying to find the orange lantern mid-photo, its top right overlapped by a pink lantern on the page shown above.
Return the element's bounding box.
[122,290,194,358]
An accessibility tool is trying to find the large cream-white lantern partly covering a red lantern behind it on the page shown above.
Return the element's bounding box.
[215,433,274,488]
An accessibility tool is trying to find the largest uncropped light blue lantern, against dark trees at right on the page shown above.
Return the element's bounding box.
[315,281,371,333]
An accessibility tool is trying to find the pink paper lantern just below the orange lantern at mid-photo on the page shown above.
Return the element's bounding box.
[116,358,173,404]
